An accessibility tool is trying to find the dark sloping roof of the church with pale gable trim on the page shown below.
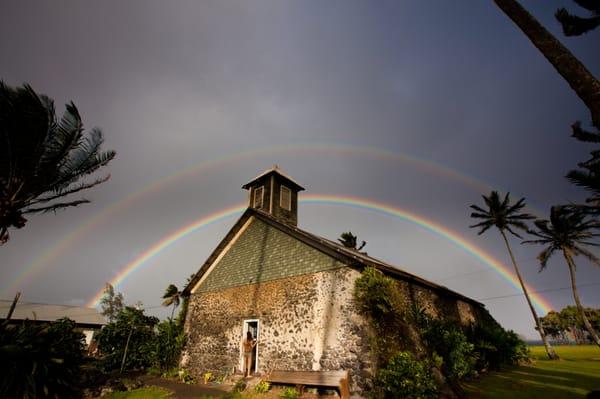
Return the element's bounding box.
[183,208,484,307]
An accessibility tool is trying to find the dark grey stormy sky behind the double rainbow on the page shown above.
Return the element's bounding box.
[0,0,600,336]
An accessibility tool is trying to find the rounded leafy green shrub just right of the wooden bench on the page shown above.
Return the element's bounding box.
[374,352,437,399]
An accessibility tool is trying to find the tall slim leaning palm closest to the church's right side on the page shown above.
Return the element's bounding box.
[469,191,558,359]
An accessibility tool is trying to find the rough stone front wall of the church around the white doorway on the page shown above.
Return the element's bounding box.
[182,268,371,394]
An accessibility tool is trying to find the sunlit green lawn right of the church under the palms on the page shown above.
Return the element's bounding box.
[465,345,600,399]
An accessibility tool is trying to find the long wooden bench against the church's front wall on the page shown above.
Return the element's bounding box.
[266,370,350,399]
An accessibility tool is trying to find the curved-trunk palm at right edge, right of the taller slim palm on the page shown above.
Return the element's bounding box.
[524,206,600,346]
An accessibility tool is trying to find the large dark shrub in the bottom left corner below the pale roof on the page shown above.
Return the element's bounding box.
[0,318,84,398]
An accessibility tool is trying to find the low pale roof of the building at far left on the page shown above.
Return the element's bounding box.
[0,300,107,327]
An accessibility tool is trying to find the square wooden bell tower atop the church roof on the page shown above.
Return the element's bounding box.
[242,165,304,226]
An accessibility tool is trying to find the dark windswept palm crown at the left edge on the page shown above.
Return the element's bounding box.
[0,81,115,244]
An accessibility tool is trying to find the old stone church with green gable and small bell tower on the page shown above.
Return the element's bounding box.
[181,167,490,396]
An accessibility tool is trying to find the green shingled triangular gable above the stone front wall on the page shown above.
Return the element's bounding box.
[198,218,345,292]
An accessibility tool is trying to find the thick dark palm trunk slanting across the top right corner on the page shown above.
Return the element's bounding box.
[494,0,600,128]
